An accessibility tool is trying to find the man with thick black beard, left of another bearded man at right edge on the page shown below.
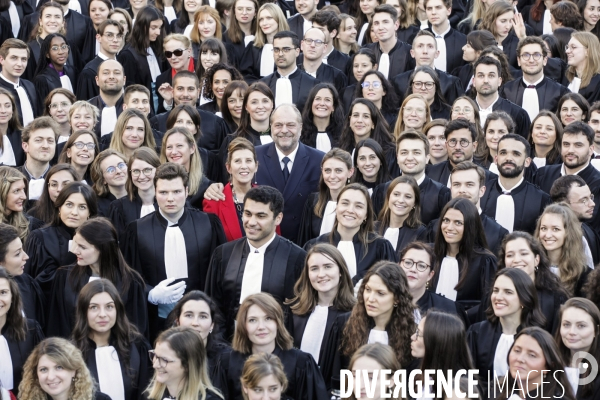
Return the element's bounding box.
[481,133,550,234]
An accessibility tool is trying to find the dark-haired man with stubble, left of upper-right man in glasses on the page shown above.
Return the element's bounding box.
[473,56,531,138]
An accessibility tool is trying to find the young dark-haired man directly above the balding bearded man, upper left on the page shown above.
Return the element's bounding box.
[75,19,124,101]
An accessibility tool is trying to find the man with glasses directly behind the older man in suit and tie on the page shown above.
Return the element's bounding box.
[260,31,319,110]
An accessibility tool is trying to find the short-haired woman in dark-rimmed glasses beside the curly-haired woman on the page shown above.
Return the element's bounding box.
[399,241,468,325]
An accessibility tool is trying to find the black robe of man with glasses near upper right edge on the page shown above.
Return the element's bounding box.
[498,77,571,113]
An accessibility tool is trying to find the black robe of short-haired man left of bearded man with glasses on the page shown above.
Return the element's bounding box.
[371,176,451,225]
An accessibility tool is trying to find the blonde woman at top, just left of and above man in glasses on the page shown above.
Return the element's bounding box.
[239,3,290,84]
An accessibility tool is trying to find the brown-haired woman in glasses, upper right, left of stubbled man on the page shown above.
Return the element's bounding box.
[406,65,451,122]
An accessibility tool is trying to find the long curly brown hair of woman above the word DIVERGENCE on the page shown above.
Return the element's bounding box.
[340,261,416,367]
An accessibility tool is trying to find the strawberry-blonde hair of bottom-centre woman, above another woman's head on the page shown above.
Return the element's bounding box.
[231,293,294,354]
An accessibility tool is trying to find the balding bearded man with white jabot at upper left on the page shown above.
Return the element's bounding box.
[89,60,125,139]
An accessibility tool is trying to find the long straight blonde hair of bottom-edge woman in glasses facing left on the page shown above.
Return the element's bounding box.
[145,326,223,400]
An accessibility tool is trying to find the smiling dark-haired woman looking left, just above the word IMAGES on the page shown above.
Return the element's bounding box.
[468,268,546,387]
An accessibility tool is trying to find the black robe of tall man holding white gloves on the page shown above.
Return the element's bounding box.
[122,207,227,337]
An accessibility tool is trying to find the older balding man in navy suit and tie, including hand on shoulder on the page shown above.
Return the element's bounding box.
[204,104,325,242]
